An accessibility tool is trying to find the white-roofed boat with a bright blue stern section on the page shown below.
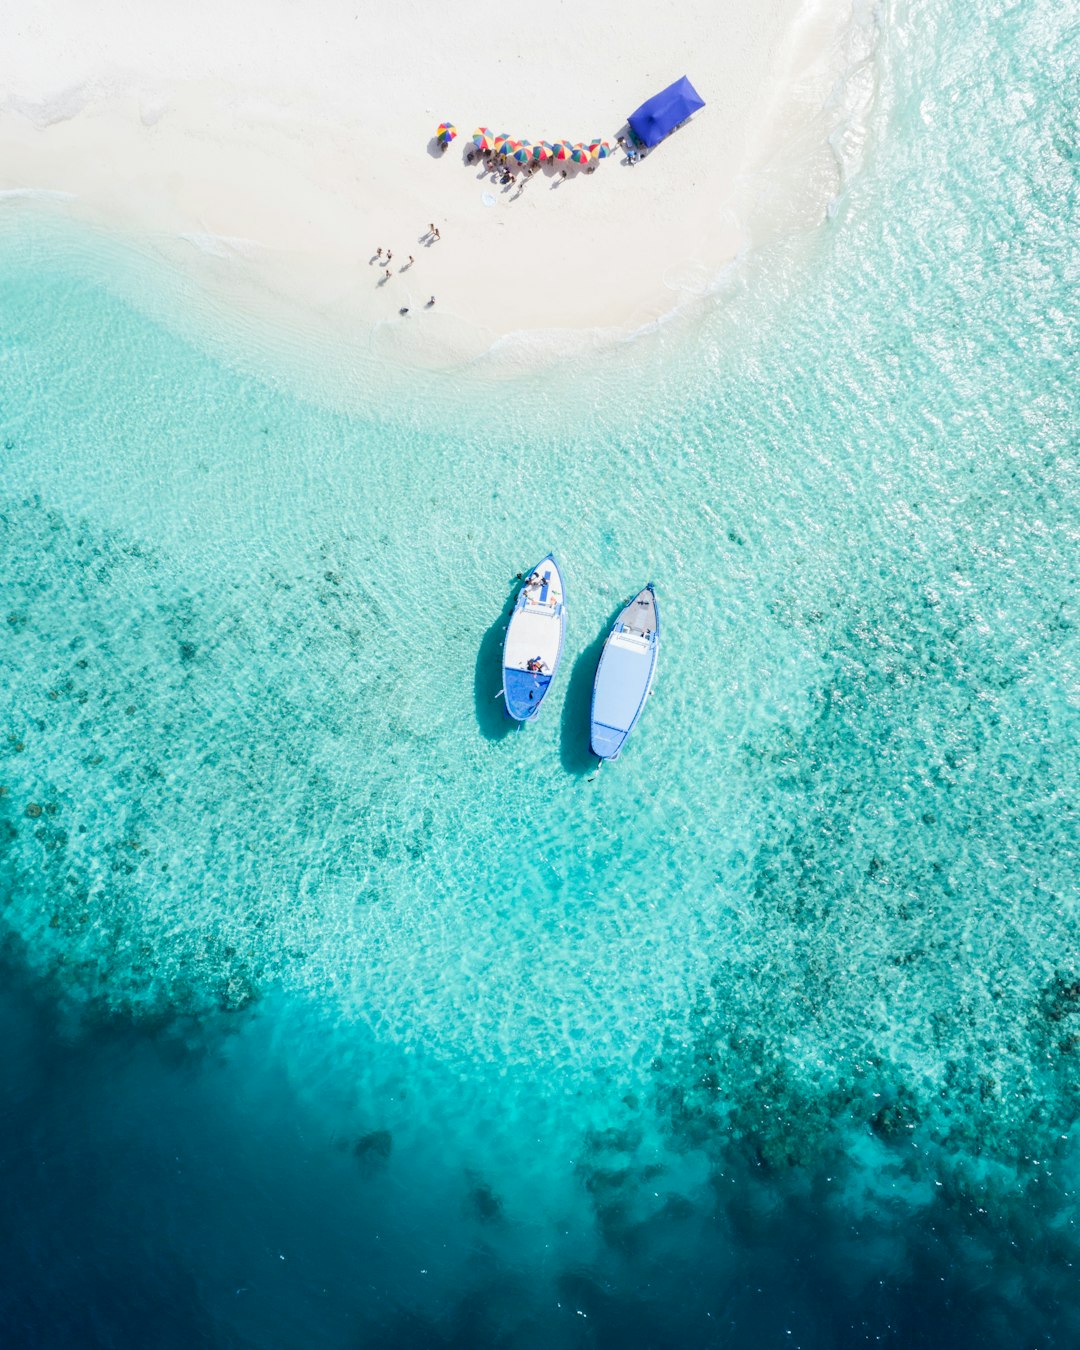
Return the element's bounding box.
[502,554,566,722]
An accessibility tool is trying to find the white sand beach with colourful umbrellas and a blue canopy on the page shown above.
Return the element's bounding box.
[0,0,851,366]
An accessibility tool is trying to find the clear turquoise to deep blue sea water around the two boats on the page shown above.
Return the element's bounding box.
[0,0,1080,1347]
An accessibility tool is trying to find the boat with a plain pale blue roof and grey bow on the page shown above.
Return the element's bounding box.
[589,582,660,760]
